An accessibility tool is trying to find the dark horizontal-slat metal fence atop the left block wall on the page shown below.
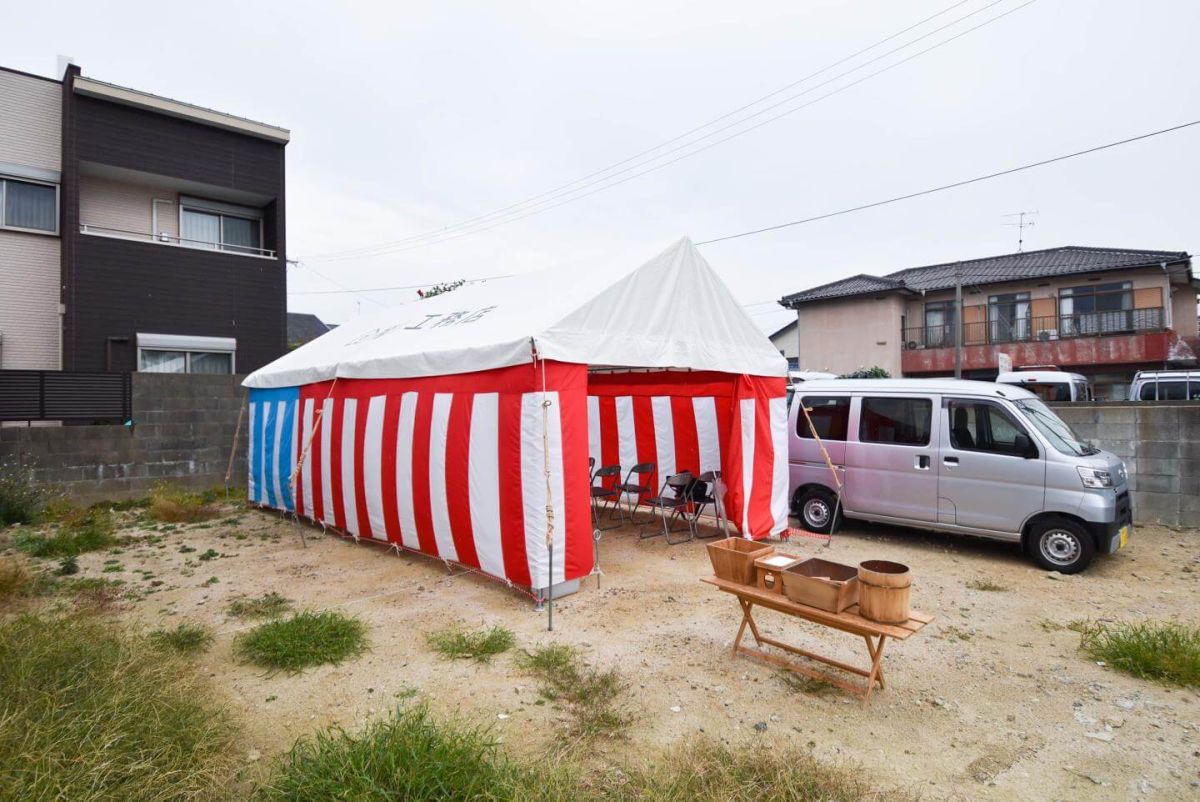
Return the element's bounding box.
[0,370,133,421]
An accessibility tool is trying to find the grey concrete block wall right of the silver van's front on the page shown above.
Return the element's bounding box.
[1054,402,1200,527]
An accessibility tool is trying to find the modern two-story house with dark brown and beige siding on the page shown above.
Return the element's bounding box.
[0,65,289,373]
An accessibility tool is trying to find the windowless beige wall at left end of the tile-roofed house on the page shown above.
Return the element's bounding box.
[799,295,905,377]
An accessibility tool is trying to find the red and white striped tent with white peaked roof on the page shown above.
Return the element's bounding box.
[245,239,787,588]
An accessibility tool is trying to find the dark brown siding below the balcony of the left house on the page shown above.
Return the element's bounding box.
[74,235,287,373]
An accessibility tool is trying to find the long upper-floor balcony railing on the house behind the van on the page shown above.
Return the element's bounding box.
[904,307,1165,351]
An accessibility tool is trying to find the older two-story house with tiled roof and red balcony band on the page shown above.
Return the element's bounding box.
[780,246,1200,399]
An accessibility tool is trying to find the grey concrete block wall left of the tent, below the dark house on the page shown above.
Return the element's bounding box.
[0,373,247,504]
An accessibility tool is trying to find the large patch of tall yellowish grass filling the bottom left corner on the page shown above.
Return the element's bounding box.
[0,615,238,800]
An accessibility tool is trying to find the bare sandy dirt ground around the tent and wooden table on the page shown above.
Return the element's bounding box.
[68,511,1200,800]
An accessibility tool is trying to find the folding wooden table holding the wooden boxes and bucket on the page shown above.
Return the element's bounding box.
[700,576,934,705]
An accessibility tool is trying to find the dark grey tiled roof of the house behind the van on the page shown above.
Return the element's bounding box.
[779,245,1192,306]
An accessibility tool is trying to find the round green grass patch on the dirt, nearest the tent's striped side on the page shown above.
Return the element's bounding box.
[234,610,367,674]
